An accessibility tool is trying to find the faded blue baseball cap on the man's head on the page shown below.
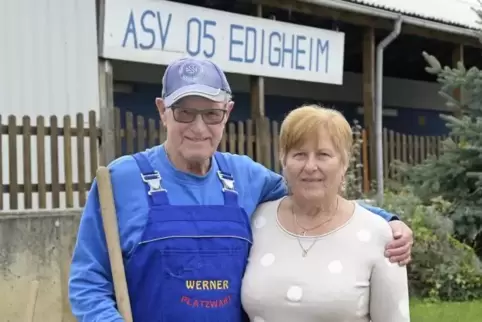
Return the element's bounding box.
[162,58,231,107]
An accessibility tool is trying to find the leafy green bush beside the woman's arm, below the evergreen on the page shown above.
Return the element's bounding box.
[380,188,482,301]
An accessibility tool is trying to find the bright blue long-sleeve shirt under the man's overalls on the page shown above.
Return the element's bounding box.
[69,145,393,322]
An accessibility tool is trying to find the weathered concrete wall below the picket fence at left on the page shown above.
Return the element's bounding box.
[0,209,80,322]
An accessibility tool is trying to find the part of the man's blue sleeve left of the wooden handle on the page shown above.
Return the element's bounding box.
[69,181,124,322]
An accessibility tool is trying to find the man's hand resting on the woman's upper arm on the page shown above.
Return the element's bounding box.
[385,220,413,266]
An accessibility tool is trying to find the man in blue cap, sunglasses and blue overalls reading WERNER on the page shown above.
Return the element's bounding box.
[69,58,412,322]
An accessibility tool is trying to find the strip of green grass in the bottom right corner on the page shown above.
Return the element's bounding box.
[410,299,482,322]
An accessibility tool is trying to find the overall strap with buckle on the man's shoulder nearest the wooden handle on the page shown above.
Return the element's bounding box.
[132,153,169,206]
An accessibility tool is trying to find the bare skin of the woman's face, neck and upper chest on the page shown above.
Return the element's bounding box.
[279,135,355,236]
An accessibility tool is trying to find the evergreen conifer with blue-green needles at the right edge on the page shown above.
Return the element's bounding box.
[403,43,482,256]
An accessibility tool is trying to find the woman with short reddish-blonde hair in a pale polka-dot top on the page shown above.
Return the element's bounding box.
[242,106,410,322]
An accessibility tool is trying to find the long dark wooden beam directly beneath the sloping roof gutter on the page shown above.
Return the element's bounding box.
[253,0,482,48]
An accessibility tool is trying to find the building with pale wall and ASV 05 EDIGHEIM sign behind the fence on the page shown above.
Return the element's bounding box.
[0,0,480,209]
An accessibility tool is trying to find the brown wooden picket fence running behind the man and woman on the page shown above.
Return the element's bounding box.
[0,109,448,210]
